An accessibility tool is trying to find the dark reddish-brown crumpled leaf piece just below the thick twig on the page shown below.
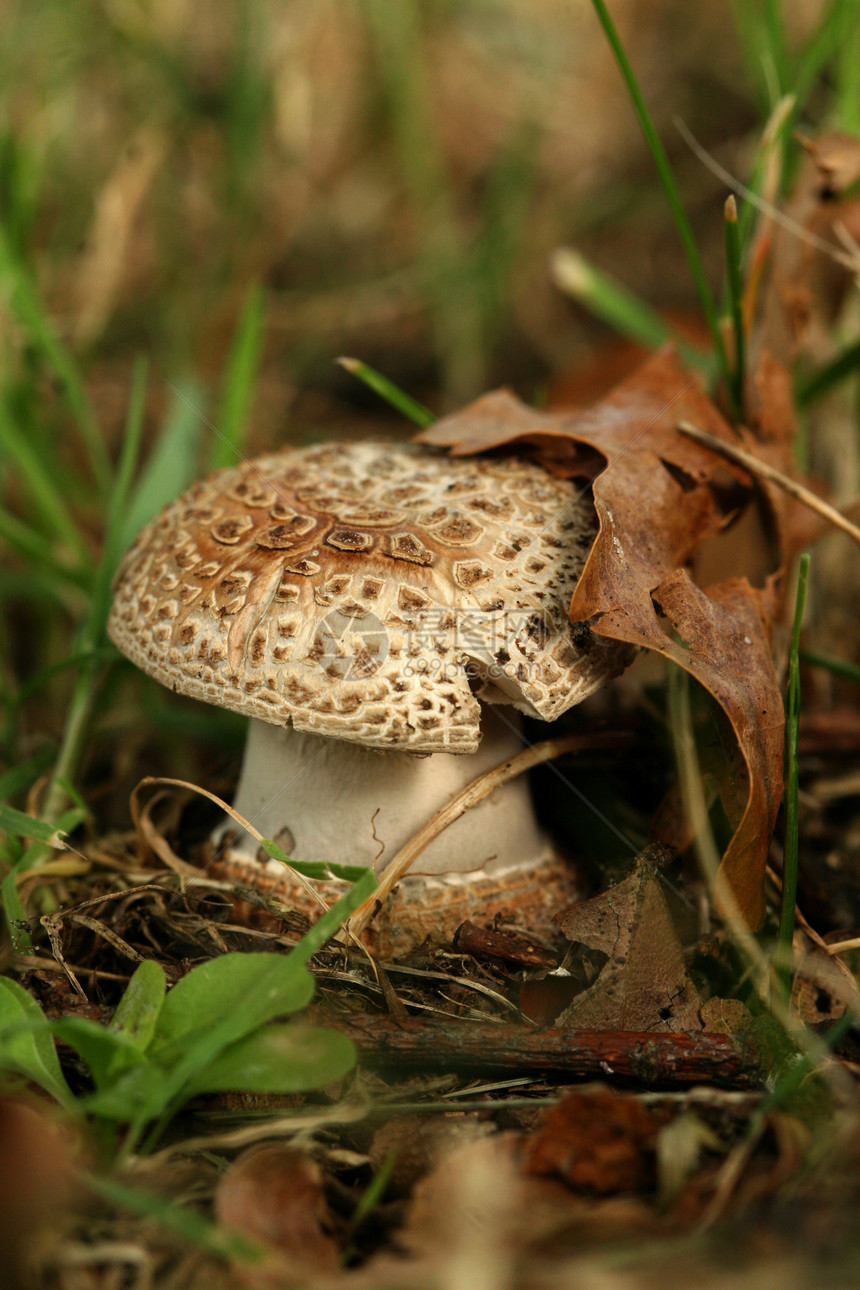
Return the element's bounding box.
[525,1089,669,1196]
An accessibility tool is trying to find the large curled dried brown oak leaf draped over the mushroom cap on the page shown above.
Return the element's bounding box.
[418,351,783,926]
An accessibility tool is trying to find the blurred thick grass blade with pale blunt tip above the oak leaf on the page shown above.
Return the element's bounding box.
[551,246,714,377]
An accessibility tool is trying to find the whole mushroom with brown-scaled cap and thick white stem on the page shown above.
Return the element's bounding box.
[108,441,629,944]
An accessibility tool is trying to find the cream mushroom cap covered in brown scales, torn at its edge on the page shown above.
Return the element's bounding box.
[108,442,629,752]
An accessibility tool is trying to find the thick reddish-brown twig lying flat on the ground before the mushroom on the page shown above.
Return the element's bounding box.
[326,1014,763,1089]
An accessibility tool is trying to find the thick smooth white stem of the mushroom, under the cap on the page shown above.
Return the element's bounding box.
[220,708,552,877]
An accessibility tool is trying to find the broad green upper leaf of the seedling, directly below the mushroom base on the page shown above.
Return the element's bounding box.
[150,953,313,1066]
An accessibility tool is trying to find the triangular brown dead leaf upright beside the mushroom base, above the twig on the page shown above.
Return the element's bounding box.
[557,851,701,1033]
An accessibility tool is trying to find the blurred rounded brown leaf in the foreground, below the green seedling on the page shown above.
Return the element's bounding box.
[215,1143,339,1286]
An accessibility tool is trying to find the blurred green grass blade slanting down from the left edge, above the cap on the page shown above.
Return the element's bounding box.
[0,228,113,497]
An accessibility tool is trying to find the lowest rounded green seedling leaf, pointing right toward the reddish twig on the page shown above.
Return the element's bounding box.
[186,1022,356,1094]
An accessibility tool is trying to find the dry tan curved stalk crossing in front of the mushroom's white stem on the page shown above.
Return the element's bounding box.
[347,734,618,937]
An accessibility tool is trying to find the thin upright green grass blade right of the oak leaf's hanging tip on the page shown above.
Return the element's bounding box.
[776,552,810,998]
